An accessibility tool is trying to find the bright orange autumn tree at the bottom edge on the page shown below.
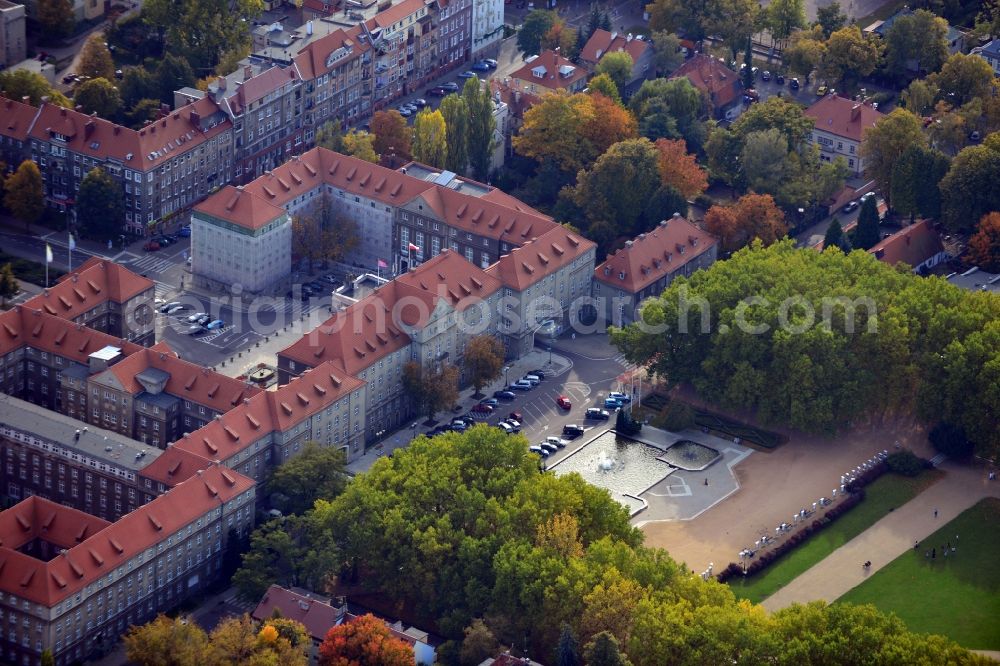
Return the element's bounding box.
[319,614,415,666]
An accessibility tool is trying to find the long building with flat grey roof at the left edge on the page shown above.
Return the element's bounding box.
[0,394,160,520]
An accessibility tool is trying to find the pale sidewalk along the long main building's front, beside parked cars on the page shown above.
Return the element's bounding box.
[347,349,573,474]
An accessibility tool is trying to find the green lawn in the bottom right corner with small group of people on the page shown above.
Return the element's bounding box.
[837,498,1000,650]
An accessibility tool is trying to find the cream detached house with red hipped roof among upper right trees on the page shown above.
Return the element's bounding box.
[805,95,885,176]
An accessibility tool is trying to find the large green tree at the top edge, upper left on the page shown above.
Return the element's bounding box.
[142,0,264,71]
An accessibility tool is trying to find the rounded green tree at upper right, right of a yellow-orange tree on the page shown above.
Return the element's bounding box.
[885,9,948,77]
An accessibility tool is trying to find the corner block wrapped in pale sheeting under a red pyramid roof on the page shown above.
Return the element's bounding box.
[191,185,292,293]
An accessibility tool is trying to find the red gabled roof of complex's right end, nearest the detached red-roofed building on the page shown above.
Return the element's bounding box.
[486,225,596,291]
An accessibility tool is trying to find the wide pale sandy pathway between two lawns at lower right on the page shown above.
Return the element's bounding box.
[761,461,1000,611]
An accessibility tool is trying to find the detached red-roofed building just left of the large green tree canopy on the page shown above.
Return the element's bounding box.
[594,213,718,326]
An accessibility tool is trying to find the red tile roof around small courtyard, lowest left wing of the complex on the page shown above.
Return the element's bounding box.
[0,465,254,607]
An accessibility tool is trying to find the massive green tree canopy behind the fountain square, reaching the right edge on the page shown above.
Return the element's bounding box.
[612,241,1000,454]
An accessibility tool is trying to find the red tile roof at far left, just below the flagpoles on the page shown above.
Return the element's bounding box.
[24,257,155,319]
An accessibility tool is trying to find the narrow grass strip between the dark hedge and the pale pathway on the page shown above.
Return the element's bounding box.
[729,470,944,603]
